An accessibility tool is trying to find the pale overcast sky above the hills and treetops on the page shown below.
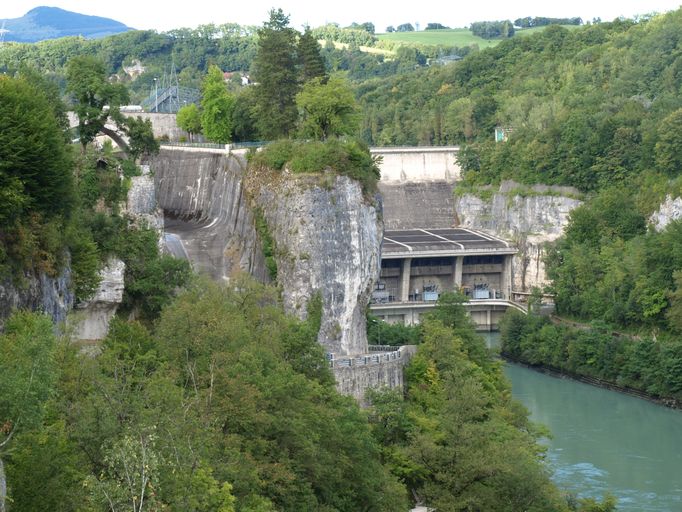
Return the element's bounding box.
[0,0,680,32]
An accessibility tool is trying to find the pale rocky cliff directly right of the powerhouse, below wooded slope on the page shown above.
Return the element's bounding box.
[455,182,582,291]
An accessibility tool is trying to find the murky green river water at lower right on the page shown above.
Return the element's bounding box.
[480,333,682,512]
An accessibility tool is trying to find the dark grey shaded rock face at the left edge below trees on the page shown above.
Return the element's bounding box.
[0,264,74,328]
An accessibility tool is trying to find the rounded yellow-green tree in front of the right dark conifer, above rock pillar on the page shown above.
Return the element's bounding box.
[296,77,360,140]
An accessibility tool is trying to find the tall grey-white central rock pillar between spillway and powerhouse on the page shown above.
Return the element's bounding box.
[250,173,383,354]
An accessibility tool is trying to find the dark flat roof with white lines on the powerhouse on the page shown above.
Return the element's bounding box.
[381,228,517,259]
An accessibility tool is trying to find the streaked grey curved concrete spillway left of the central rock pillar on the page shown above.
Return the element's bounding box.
[148,150,268,281]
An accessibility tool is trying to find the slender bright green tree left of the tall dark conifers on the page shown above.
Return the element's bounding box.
[201,66,235,144]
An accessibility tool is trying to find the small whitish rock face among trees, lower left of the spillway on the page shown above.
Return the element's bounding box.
[74,258,125,340]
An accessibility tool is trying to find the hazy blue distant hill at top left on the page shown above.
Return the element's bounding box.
[0,7,133,43]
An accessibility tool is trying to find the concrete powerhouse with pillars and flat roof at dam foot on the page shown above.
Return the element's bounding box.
[370,228,520,330]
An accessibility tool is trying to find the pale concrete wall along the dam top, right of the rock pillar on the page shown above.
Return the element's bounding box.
[370,146,461,183]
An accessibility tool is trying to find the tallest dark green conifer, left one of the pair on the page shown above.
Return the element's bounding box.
[252,9,299,139]
